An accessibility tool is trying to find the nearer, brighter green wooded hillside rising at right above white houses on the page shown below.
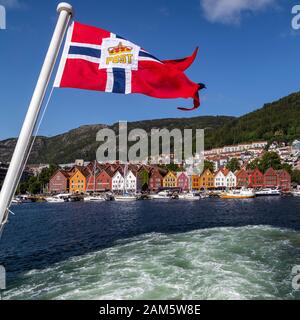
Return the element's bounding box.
[205,92,300,147]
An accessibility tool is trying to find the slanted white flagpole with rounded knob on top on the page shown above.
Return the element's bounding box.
[0,2,73,230]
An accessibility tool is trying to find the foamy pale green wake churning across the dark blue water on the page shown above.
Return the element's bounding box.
[4,226,300,299]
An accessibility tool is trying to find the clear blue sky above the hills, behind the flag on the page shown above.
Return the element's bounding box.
[0,0,300,139]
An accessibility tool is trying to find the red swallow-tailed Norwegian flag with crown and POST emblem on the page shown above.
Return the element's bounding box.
[54,22,205,110]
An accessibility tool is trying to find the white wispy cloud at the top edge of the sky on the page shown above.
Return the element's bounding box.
[200,0,276,24]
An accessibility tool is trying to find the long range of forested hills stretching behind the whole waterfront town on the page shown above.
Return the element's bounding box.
[0,92,300,163]
